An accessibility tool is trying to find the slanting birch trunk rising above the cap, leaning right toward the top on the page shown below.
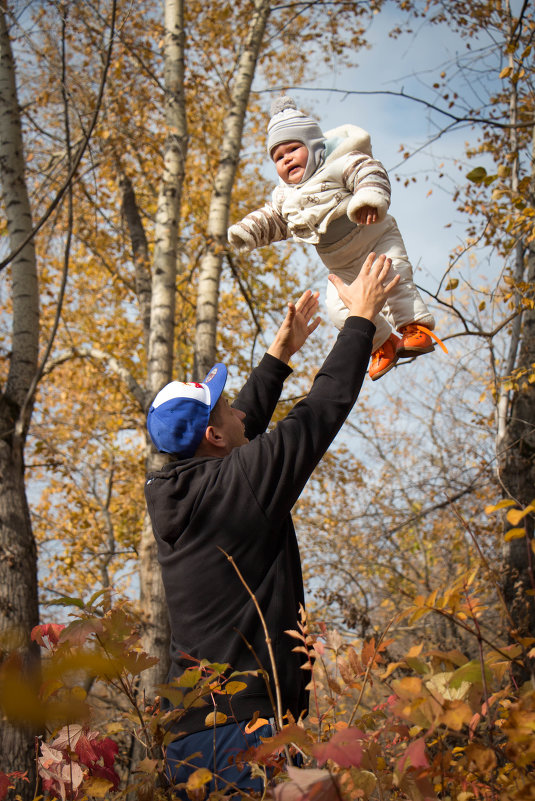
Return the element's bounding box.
[193,0,271,380]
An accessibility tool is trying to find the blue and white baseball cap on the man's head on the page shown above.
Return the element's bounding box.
[147,362,227,459]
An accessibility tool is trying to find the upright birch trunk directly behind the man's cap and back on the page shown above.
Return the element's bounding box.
[140,0,188,696]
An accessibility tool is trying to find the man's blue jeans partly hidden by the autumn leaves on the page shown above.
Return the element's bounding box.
[166,721,274,801]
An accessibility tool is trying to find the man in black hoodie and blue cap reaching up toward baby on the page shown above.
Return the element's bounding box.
[145,253,399,797]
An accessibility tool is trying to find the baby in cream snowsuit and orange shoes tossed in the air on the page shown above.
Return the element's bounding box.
[228,96,437,381]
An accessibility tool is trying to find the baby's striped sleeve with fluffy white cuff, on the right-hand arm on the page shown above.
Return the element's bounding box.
[342,151,390,222]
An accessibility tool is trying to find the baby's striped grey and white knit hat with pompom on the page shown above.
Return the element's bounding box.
[267,95,325,183]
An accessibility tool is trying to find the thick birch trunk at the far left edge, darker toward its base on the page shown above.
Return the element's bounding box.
[0,7,39,780]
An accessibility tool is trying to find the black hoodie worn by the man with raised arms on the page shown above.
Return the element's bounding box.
[145,317,375,733]
